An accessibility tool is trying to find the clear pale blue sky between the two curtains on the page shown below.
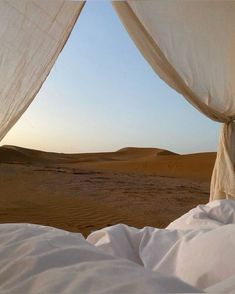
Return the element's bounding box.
[1,1,220,154]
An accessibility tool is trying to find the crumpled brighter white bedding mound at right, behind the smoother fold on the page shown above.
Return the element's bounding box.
[88,200,235,293]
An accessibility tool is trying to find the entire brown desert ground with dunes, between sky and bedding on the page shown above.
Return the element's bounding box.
[0,146,215,236]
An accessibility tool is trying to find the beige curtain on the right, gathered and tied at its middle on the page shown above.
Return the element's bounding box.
[113,0,235,200]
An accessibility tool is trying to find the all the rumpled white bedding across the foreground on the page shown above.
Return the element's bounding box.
[0,200,235,293]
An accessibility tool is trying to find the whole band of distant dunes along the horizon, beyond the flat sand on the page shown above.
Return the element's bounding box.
[0,145,215,181]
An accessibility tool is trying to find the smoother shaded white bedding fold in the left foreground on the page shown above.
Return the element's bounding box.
[0,224,200,294]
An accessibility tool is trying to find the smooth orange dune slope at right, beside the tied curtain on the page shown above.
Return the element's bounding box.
[80,152,215,181]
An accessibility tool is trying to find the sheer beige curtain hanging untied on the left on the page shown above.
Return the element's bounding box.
[0,0,84,140]
